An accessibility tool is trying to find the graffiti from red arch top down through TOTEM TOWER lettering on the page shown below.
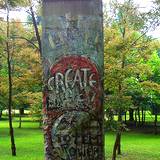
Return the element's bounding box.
[44,55,103,160]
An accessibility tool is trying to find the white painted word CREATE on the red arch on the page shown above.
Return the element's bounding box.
[48,68,96,91]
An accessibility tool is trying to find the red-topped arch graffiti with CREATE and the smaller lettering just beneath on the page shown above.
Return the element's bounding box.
[47,56,100,111]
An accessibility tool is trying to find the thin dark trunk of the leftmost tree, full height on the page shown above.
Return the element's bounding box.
[6,1,16,156]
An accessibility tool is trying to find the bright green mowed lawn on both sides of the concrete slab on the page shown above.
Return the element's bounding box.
[0,118,160,160]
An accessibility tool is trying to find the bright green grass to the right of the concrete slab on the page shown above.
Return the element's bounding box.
[105,132,160,160]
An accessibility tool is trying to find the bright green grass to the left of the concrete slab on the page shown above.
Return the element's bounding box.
[0,118,44,160]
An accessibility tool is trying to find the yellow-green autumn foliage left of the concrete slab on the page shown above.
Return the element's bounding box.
[0,16,42,114]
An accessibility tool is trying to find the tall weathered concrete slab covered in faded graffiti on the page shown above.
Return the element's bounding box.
[42,0,104,160]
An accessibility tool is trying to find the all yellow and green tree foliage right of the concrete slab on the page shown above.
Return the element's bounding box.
[104,0,160,135]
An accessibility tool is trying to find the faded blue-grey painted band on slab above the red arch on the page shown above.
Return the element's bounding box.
[44,13,103,63]
